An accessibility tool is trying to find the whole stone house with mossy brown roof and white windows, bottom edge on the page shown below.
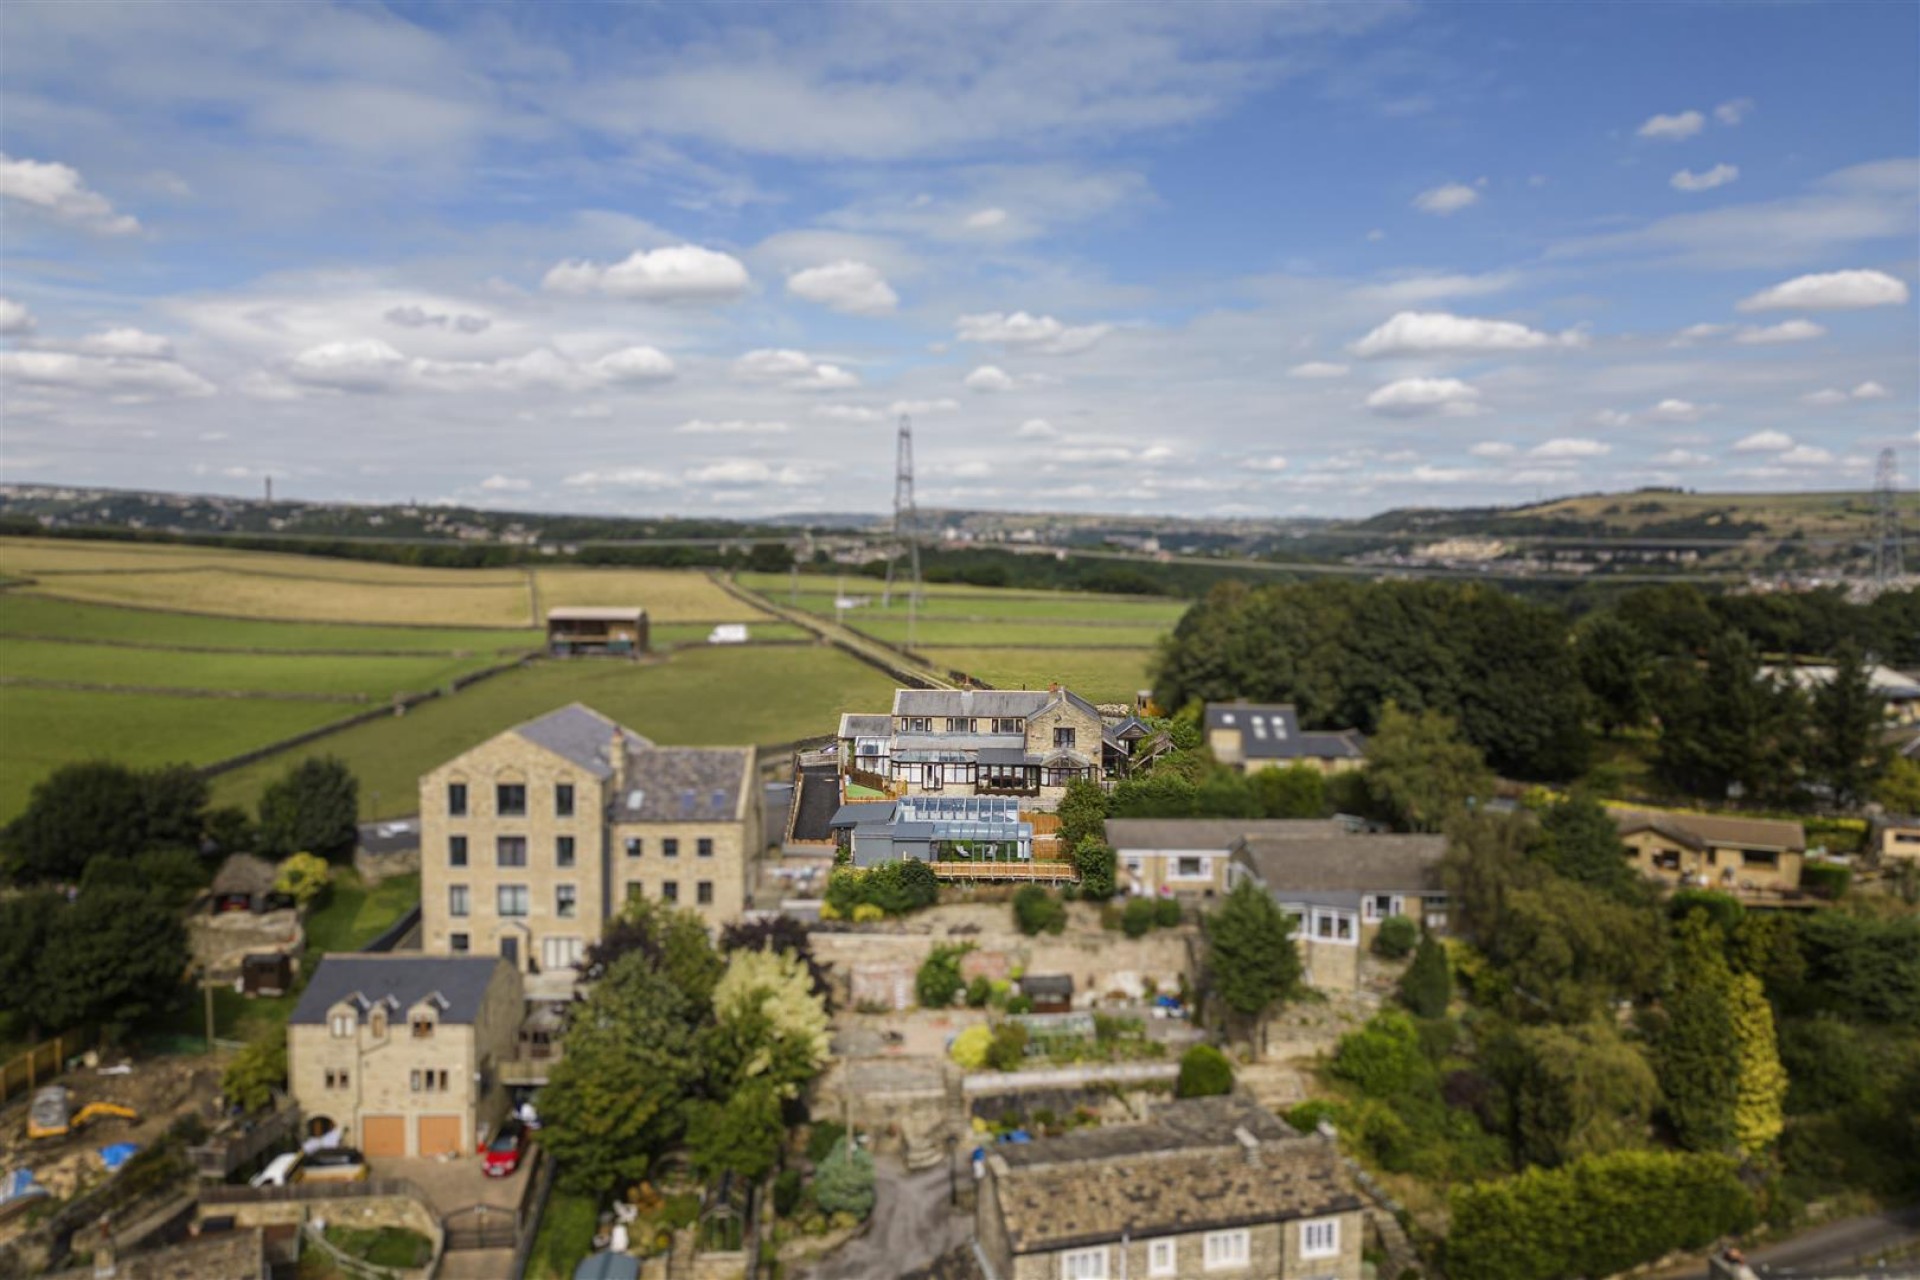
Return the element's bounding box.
[975,1098,1363,1280]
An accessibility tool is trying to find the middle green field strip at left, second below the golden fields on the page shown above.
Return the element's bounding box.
[0,639,501,694]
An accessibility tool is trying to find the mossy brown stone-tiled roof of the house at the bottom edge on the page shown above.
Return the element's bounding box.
[989,1098,1361,1253]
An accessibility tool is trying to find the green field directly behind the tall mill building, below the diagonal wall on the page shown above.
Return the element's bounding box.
[213,645,893,818]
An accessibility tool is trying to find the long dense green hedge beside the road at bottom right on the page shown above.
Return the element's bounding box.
[1446,1151,1755,1280]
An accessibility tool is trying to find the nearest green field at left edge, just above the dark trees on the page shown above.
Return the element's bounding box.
[0,690,355,821]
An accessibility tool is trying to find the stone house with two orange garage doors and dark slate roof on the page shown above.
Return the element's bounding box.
[286,952,524,1155]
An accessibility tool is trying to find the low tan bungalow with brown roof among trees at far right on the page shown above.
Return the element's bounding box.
[1613,810,1807,892]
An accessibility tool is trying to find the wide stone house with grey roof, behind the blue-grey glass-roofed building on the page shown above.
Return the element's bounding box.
[839,685,1127,808]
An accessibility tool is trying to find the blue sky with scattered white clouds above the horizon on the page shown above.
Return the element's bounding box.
[0,4,1920,514]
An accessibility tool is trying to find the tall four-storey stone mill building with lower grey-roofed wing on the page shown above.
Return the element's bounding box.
[420,702,760,996]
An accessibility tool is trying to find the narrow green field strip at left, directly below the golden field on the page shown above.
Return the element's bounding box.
[0,594,545,654]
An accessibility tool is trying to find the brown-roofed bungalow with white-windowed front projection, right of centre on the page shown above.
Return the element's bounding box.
[1227,835,1448,988]
